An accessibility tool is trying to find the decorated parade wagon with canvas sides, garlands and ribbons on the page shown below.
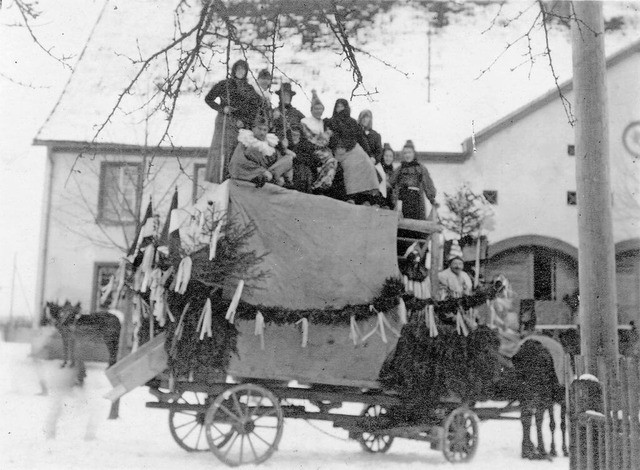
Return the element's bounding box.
[102,181,564,466]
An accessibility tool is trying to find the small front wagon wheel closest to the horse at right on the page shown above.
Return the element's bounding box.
[442,407,479,463]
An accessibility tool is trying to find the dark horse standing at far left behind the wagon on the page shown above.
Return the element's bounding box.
[46,301,120,367]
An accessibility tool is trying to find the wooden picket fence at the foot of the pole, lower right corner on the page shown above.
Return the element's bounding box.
[566,356,640,470]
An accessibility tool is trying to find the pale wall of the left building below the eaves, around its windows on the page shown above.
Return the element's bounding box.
[42,151,205,312]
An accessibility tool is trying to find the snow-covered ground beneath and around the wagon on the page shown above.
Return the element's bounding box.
[0,342,569,470]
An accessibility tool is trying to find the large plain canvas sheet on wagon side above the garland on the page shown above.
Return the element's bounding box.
[227,181,399,309]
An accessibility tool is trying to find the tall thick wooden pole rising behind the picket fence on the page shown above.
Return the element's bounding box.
[571,1,618,375]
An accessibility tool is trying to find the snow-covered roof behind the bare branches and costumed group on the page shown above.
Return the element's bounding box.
[36,0,640,152]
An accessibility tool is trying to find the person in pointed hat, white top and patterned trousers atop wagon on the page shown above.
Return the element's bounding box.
[300,90,338,193]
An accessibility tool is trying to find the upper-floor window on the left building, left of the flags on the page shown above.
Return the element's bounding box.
[98,162,142,224]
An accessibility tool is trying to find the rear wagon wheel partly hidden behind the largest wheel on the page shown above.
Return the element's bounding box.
[169,392,232,452]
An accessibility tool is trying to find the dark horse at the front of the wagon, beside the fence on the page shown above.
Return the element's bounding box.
[507,339,568,460]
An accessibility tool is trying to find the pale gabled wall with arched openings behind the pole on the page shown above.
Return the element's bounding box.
[426,49,640,324]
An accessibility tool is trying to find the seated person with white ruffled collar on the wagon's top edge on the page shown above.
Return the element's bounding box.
[229,115,295,187]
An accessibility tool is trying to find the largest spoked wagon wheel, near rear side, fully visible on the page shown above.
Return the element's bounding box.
[204,383,284,467]
